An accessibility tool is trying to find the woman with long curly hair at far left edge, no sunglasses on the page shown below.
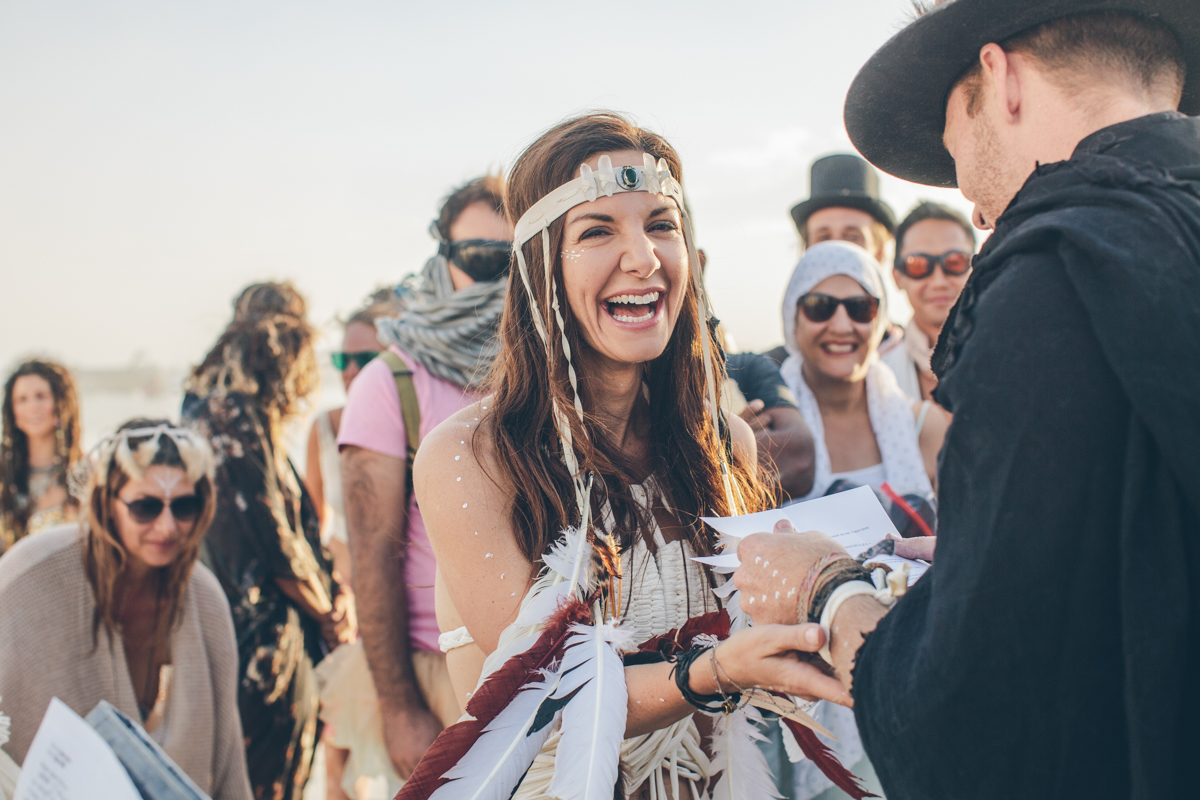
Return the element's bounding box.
[0,359,80,553]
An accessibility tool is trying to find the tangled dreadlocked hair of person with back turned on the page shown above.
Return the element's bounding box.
[186,282,320,425]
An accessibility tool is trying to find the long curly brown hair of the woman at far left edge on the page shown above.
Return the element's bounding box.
[0,359,80,553]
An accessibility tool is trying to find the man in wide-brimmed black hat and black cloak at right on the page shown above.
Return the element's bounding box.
[734,0,1200,800]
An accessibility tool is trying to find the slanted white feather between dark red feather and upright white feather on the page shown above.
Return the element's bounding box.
[430,670,562,800]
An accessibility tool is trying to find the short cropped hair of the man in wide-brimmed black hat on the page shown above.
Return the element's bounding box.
[955,10,1187,116]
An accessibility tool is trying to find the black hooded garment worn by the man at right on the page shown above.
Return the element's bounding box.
[853,113,1200,800]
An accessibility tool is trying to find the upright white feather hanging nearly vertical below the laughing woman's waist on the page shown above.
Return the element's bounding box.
[548,624,635,800]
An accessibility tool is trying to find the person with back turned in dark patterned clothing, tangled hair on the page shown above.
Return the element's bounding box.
[184,283,354,800]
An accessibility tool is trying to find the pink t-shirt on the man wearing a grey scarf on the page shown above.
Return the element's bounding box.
[337,347,476,652]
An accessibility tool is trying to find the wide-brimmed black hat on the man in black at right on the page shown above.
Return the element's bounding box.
[845,0,1200,186]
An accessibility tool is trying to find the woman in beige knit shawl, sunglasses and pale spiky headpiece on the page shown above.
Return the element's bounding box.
[0,420,251,800]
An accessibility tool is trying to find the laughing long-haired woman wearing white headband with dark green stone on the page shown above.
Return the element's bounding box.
[412,114,854,799]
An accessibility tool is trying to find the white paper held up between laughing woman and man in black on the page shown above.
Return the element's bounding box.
[694,486,929,585]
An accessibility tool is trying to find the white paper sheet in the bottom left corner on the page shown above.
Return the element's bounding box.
[13,698,142,800]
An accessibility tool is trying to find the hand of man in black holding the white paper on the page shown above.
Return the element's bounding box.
[733,519,846,625]
